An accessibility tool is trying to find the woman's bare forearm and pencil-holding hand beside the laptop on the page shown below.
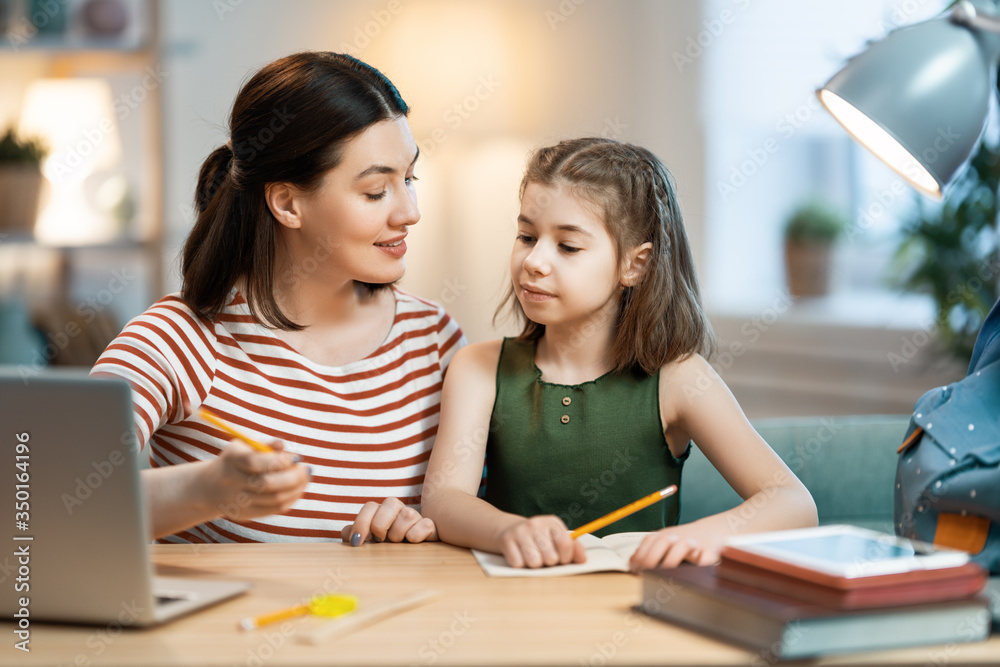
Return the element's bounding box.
[142,440,309,539]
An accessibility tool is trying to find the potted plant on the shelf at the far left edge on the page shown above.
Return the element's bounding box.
[0,129,47,236]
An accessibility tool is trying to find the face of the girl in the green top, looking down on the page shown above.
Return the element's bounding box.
[510,183,620,326]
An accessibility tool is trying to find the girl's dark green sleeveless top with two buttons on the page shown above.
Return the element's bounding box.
[485,338,690,537]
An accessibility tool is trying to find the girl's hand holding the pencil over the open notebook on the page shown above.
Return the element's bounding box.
[499,515,587,567]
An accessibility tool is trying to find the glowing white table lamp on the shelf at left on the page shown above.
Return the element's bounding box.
[18,78,122,245]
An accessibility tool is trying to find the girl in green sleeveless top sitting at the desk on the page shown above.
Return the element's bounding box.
[423,138,816,569]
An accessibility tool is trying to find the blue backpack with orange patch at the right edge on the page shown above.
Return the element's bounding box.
[894,301,1000,574]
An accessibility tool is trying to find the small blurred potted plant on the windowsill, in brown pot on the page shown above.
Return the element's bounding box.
[784,201,846,297]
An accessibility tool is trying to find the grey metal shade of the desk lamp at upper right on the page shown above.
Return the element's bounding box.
[817,18,1000,198]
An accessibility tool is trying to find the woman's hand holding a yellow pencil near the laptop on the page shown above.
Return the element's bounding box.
[200,439,309,522]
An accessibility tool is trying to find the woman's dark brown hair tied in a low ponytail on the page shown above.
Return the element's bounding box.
[182,52,410,330]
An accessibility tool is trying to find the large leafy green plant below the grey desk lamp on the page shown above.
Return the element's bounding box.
[895,141,1000,363]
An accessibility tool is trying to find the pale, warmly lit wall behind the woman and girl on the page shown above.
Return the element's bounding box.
[161,0,704,340]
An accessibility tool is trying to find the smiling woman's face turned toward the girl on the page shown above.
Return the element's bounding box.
[286,116,420,283]
